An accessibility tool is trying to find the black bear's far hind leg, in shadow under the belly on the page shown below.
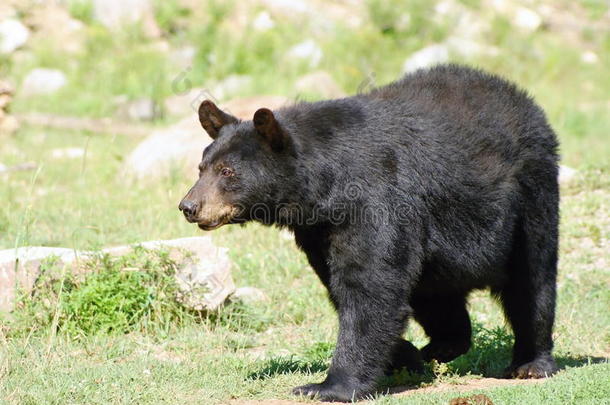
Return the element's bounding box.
[412,294,472,363]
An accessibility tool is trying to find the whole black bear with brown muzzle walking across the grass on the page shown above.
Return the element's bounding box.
[179,65,559,401]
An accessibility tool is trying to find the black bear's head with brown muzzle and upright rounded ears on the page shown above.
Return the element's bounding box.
[179,100,295,230]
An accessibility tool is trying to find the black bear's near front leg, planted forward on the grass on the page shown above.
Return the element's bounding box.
[293,243,413,402]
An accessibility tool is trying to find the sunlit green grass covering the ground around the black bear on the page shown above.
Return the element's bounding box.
[0,0,610,404]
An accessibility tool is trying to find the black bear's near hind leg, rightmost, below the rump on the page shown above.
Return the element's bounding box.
[499,173,558,378]
